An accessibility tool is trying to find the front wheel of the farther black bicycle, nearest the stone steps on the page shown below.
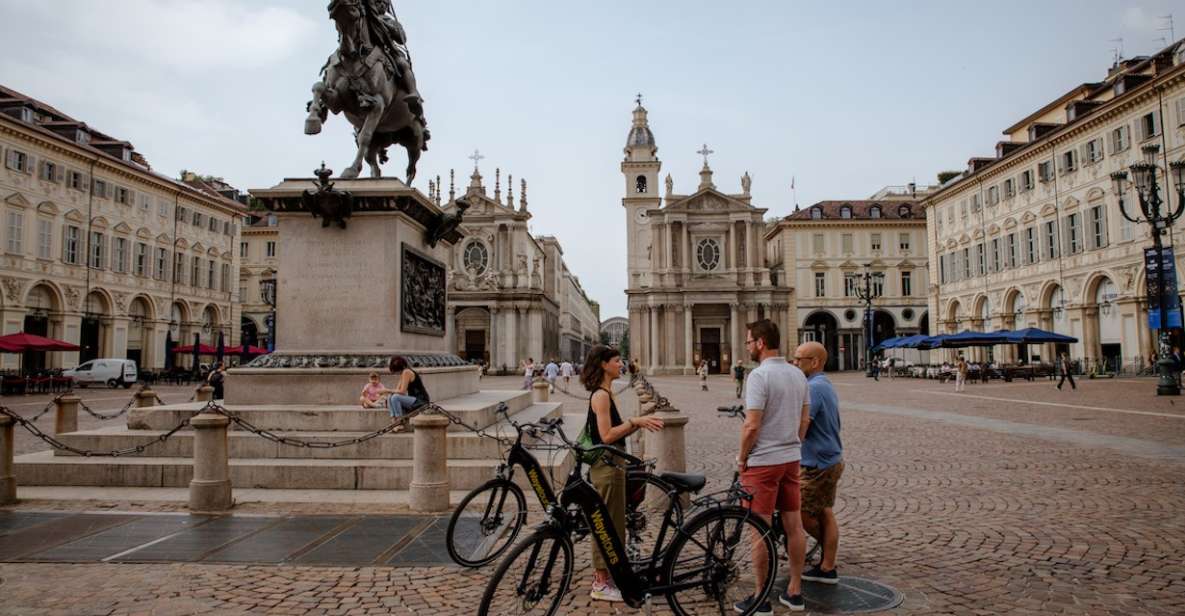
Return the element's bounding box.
[444,479,526,567]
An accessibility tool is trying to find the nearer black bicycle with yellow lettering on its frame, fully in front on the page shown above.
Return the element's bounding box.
[478,419,777,616]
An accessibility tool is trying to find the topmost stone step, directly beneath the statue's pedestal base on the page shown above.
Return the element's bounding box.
[127,390,531,432]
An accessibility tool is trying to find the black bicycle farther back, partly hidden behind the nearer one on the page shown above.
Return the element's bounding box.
[444,404,683,567]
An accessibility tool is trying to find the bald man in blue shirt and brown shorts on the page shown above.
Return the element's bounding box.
[794,342,844,584]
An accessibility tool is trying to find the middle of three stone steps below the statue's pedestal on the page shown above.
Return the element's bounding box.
[53,403,561,460]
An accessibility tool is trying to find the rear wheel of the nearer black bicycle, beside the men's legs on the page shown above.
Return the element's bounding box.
[665,507,777,616]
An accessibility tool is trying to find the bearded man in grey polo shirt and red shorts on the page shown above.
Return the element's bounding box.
[736,319,811,615]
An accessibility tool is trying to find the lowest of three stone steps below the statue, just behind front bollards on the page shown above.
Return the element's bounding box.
[14,451,571,494]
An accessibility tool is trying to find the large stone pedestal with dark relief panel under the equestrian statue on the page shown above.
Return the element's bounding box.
[226,178,479,405]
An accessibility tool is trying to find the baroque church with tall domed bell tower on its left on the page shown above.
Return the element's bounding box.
[621,100,798,374]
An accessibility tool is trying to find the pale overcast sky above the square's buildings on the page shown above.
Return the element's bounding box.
[0,0,1185,319]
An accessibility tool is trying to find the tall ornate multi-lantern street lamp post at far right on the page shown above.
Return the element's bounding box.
[1112,145,1185,396]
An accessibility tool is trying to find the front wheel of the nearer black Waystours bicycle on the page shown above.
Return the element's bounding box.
[478,527,575,616]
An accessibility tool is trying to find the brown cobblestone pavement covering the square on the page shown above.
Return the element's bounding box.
[0,374,1185,616]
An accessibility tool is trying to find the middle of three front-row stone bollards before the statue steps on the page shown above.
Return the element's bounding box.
[190,412,235,513]
